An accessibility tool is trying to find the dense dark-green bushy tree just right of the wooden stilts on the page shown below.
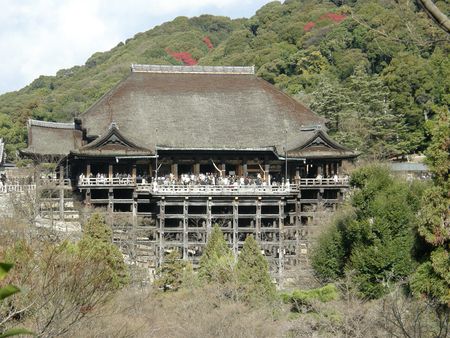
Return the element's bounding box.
[312,165,423,298]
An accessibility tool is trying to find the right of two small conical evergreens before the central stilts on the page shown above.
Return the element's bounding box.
[236,235,276,303]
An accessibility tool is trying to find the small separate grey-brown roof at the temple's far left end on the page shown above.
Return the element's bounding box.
[21,120,82,156]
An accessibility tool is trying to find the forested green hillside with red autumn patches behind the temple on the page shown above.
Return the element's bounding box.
[0,0,450,160]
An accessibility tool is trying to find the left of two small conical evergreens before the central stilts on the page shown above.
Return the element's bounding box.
[199,225,234,284]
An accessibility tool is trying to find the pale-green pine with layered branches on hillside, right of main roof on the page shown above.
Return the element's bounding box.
[311,67,405,158]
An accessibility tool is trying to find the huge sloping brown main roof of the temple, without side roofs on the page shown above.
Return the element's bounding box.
[81,66,324,154]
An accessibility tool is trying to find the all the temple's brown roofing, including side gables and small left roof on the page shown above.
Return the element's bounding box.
[23,65,356,158]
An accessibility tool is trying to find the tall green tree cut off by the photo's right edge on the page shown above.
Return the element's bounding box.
[411,109,450,306]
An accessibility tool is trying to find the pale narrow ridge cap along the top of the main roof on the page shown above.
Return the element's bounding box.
[131,64,255,75]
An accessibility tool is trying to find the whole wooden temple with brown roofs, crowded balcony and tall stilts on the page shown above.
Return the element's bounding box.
[22,65,357,277]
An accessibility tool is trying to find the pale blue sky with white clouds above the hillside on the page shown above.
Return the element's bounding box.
[0,0,270,94]
